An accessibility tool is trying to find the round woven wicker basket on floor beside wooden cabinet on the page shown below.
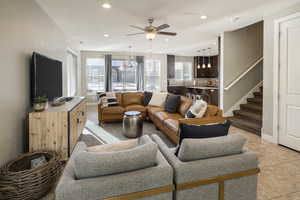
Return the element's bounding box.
[0,152,61,200]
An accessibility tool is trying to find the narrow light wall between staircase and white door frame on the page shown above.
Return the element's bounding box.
[262,3,300,136]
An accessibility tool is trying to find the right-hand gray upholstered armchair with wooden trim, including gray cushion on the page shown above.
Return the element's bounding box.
[151,135,259,200]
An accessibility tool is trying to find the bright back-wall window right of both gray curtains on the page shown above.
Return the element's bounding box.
[144,60,160,91]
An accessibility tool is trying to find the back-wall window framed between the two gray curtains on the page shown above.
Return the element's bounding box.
[112,59,137,91]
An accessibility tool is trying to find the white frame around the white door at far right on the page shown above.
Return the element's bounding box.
[274,12,300,144]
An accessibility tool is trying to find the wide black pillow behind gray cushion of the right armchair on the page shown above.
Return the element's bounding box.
[176,120,230,155]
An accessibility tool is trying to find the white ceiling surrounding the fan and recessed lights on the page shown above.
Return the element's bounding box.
[36,0,297,56]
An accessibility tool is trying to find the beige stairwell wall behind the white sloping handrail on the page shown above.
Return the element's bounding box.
[222,22,263,112]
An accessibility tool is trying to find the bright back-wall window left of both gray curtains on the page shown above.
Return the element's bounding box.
[86,58,105,92]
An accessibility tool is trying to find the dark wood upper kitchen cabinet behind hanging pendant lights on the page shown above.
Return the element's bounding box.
[194,55,219,78]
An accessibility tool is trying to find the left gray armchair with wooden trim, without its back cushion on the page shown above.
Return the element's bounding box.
[55,136,174,200]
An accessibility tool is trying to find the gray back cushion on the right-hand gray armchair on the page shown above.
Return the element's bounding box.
[178,135,247,162]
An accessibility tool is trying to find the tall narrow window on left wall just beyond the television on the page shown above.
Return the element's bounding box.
[67,51,78,96]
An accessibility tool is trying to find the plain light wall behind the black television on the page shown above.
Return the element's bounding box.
[0,0,77,165]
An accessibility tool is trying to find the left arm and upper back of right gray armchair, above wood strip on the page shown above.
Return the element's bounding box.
[151,135,258,184]
